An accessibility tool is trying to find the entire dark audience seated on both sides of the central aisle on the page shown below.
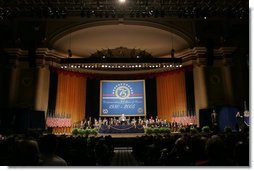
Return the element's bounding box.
[0,123,250,166]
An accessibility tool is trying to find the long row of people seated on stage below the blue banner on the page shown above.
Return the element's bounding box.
[73,115,194,130]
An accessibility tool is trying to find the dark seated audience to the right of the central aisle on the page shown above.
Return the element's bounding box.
[133,127,250,166]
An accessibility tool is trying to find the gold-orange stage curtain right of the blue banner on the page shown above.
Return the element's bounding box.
[156,70,187,121]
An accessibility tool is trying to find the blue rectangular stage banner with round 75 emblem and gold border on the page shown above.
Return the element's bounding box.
[100,80,146,116]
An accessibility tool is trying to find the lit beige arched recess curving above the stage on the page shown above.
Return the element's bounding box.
[53,22,190,57]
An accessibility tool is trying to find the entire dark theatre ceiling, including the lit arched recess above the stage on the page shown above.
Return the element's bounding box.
[0,0,249,74]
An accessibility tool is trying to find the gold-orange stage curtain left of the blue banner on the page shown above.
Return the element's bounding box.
[55,72,86,123]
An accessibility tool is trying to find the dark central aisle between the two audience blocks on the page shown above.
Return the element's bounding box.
[111,147,142,166]
